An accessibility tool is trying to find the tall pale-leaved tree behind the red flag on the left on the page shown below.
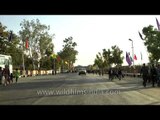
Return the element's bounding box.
[19,19,54,68]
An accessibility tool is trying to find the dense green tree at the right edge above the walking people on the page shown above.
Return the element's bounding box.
[142,25,160,63]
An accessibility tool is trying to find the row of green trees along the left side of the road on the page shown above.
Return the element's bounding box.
[0,19,78,70]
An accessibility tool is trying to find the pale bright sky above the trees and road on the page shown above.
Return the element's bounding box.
[0,15,160,66]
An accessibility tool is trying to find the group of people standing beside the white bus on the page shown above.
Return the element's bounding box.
[0,65,19,86]
